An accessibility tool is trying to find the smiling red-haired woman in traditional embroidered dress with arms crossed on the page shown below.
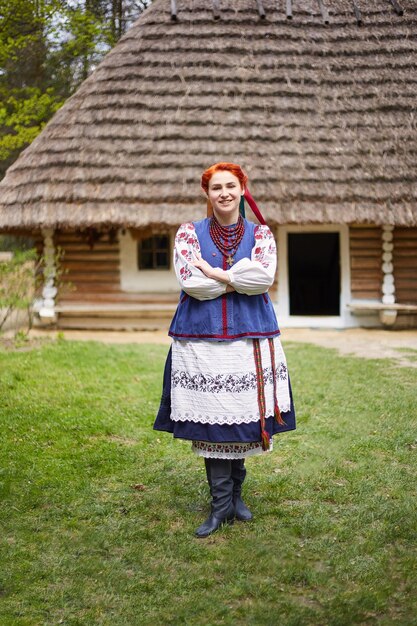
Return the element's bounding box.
[154,163,295,537]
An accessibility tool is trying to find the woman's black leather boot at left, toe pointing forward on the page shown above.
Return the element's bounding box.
[195,459,235,537]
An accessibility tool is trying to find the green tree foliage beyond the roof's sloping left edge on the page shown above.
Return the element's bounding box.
[0,0,149,178]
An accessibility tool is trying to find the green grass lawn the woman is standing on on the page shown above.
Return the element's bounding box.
[0,340,417,626]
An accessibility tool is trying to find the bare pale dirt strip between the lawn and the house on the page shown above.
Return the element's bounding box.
[17,328,417,367]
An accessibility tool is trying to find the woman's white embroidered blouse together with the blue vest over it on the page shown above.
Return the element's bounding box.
[169,219,279,341]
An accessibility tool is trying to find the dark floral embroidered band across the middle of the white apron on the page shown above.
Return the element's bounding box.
[171,362,287,393]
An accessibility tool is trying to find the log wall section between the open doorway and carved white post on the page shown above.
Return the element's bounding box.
[349,226,382,300]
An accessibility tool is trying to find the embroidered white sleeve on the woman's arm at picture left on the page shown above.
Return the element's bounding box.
[174,222,226,300]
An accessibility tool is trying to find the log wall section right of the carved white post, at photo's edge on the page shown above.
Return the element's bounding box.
[393,228,417,304]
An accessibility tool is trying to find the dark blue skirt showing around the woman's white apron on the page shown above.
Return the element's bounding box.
[153,349,295,443]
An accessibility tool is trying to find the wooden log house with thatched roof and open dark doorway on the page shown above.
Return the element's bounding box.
[0,0,417,328]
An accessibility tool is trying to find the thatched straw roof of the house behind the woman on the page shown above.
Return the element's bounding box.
[0,0,417,228]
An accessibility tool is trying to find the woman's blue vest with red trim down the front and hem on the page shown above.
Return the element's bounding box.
[169,219,280,341]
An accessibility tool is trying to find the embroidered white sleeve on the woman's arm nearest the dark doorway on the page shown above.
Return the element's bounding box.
[227,225,277,296]
